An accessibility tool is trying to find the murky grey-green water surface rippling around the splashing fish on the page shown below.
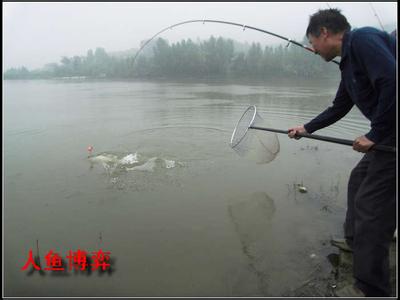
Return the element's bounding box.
[3,80,369,296]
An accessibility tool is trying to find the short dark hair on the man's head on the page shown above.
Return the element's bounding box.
[306,8,351,37]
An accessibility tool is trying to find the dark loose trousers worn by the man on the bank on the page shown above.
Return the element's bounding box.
[344,151,397,296]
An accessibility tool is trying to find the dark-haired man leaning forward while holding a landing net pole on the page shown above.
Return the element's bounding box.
[289,9,396,296]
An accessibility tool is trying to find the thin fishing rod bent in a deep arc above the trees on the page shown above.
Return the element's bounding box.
[133,19,339,65]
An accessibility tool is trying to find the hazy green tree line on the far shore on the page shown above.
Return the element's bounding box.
[4,36,338,79]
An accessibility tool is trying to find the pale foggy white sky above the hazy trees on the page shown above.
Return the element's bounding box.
[3,2,397,71]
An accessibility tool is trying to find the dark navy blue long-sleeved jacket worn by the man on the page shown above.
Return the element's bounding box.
[304,27,396,146]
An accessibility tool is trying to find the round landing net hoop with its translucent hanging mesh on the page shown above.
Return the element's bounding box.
[230,105,279,164]
